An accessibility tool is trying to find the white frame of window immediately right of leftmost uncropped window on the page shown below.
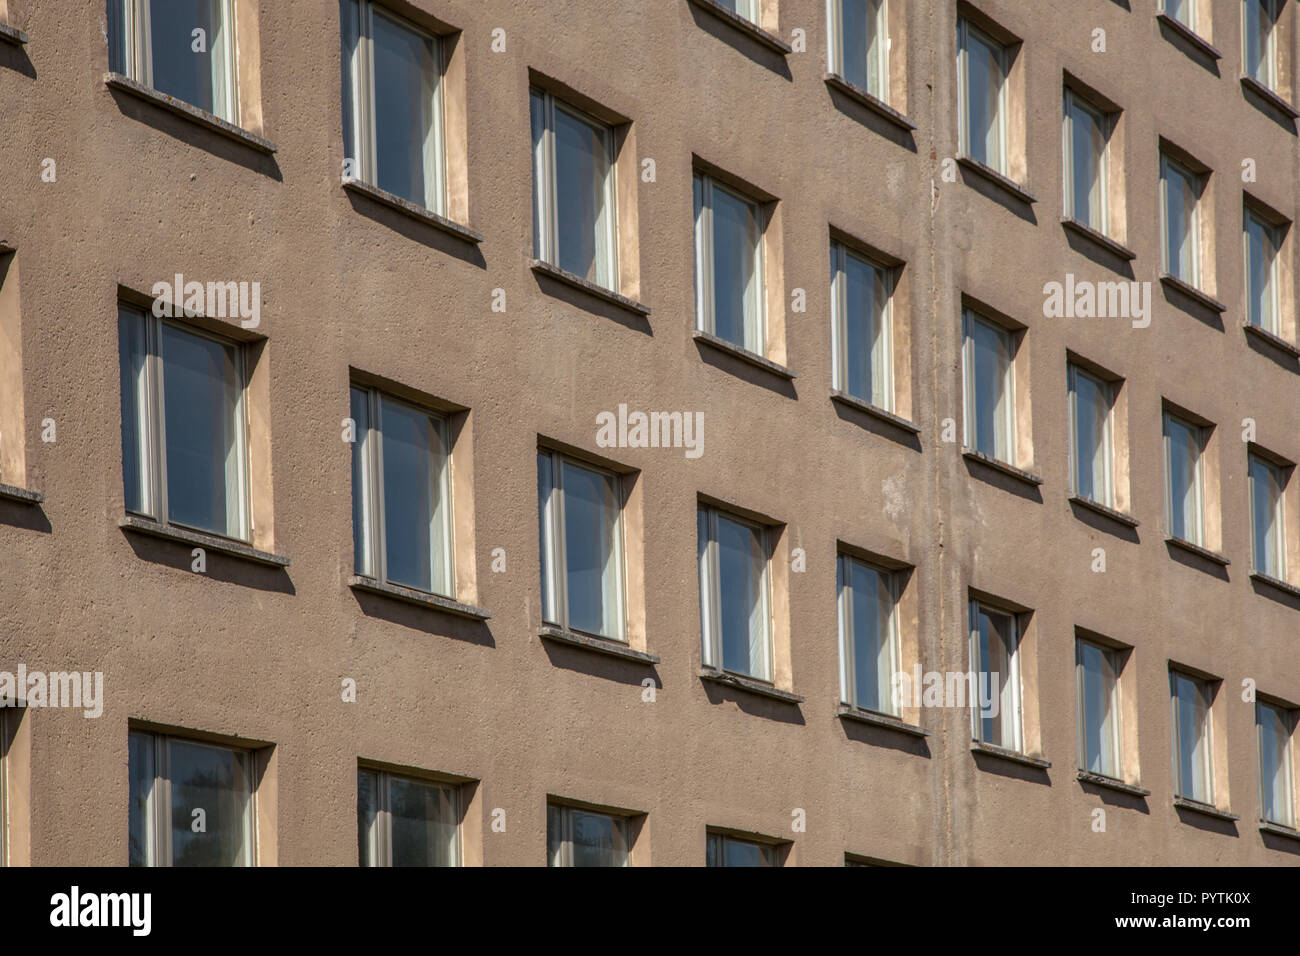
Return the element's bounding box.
[348,382,456,600]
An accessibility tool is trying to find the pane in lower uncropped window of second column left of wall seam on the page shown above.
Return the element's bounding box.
[718,515,770,680]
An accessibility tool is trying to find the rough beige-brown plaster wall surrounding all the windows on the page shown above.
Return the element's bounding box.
[0,0,1300,865]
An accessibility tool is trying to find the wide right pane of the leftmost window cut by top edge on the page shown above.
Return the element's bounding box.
[150,0,234,121]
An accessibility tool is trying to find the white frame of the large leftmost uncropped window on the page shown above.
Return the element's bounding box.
[118,303,252,544]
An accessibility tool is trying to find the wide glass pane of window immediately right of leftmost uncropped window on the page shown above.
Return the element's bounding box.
[380,398,450,594]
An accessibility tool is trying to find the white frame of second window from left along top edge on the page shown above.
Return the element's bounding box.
[343,0,447,216]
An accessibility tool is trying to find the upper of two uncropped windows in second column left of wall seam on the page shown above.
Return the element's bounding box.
[694,173,764,355]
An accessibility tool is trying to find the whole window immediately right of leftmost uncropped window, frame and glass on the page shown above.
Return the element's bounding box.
[351,386,455,597]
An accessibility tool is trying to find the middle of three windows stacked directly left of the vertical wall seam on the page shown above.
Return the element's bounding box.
[831,242,893,411]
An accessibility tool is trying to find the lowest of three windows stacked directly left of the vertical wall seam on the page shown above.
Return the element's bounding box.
[839,554,898,717]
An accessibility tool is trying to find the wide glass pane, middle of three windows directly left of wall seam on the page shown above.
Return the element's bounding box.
[844,252,891,410]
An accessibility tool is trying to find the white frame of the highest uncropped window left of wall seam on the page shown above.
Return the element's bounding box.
[528,86,620,293]
